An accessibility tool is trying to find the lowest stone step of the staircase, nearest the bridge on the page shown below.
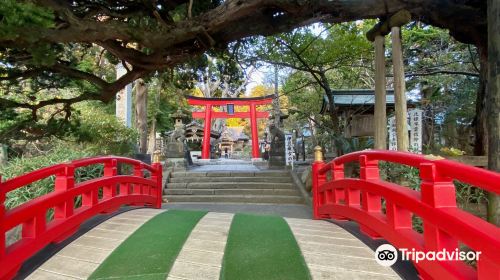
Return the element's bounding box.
[163,195,304,204]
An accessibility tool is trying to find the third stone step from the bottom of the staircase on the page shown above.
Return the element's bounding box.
[166,182,296,190]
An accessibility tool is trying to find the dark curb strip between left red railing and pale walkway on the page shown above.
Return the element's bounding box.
[13,206,156,280]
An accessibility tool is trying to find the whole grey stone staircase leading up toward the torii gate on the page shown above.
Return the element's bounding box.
[164,171,304,204]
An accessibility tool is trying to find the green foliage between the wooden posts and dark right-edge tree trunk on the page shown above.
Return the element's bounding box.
[403,22,480,154]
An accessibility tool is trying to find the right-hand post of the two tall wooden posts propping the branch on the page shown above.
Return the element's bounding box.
[391,26,409,151]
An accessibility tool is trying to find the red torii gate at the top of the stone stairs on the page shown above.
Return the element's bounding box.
[187,95,274,159]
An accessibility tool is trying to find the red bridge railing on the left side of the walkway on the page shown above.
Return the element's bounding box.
[0,157,162,279]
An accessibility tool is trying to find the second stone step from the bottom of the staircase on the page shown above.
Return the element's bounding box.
[164,189,300,196]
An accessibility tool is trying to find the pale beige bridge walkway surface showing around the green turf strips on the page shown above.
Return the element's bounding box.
[28,209,399,280]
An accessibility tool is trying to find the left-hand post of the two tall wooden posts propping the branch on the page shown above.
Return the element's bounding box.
[374,35,387,150]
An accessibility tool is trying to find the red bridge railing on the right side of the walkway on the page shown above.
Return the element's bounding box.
[313,151,500,279]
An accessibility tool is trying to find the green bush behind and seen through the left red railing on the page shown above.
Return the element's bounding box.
[0,145,103,209]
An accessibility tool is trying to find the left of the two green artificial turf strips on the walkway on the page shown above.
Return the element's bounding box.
[89,210,206,280]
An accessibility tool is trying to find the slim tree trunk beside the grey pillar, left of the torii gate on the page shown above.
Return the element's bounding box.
[135,79,148,154]
